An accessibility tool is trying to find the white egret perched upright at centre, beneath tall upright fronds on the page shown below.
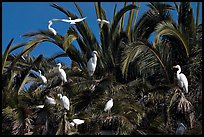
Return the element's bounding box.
[87,51,98,76]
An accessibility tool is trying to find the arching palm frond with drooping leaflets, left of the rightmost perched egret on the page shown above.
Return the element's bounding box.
[121,40,169,81]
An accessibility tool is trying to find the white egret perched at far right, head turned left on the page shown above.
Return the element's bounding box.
[173,65,188,93]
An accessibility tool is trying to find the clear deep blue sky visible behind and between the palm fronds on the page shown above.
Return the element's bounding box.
[2,2,202,65]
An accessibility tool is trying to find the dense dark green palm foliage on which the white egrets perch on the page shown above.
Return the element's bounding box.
[2,2,202,135]
